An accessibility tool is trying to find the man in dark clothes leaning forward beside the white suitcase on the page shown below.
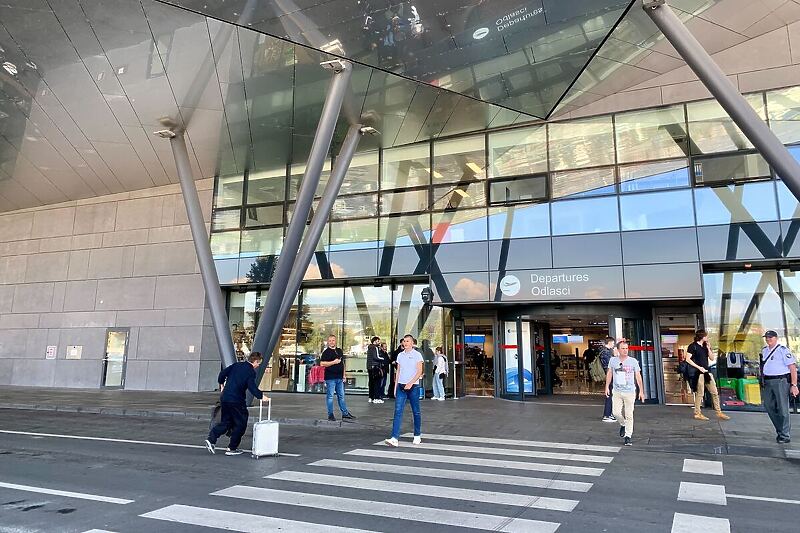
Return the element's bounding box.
[205,352,264,455]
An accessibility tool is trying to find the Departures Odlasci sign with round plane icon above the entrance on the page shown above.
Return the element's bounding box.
[491,267,625,302]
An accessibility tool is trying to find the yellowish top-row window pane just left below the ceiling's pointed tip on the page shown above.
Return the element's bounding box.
[489,126,547,178]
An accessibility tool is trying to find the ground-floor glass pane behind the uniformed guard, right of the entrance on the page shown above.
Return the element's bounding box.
[703,271,785,386]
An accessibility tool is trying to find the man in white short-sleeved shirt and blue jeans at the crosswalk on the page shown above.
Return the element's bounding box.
[386,335,423,447]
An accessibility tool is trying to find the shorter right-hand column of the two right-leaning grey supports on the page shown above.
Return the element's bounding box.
[264,124,364,354]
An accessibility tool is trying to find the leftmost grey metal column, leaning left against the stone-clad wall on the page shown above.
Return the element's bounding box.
[156,130,236,367]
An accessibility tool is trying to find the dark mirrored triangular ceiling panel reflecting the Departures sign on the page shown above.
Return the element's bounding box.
[158,0,631,117]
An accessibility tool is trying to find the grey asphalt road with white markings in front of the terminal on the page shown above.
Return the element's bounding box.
[0,407,800,533]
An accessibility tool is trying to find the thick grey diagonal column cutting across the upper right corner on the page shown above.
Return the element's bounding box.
[642,0,800,200]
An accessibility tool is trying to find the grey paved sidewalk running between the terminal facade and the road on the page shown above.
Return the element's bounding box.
[0,387,800,459]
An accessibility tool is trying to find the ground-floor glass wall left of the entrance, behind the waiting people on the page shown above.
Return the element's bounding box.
[229,284,450,392]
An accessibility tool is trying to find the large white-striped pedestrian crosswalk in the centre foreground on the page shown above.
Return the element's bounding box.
[141,435,620,533]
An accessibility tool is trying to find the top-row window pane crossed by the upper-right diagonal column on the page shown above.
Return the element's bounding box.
[686,93,766,154]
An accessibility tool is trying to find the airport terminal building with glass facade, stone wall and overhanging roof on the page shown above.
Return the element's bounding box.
[0,0,800,409]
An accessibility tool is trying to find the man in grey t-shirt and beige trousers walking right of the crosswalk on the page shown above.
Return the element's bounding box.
[606,341,644,446]
